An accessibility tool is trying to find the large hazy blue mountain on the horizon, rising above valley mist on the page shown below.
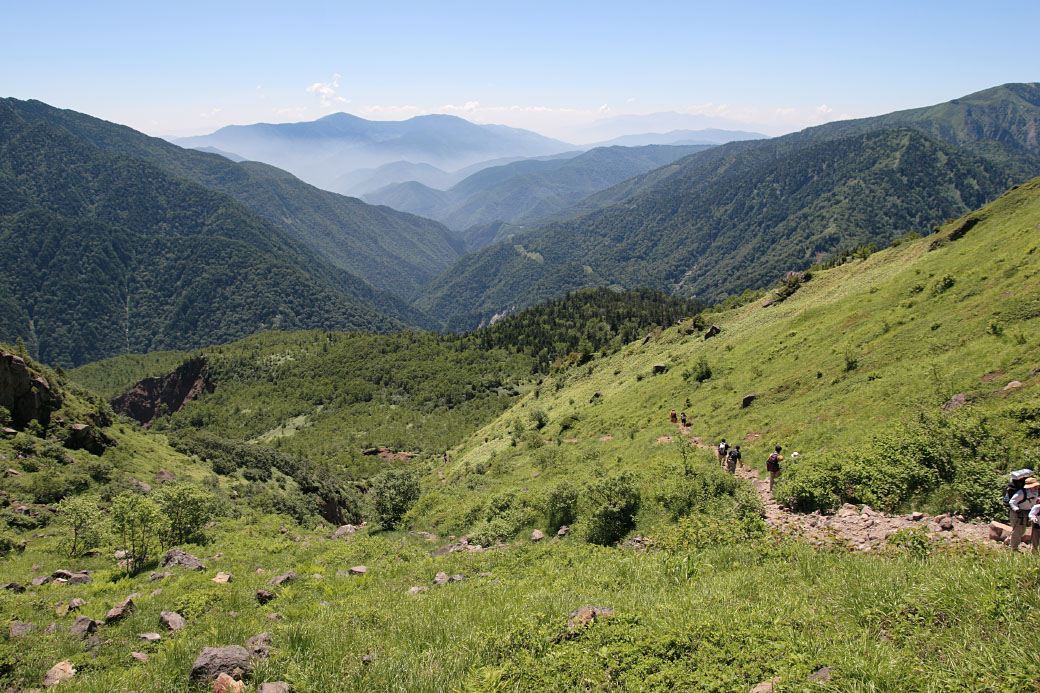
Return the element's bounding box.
[175,113,574,189]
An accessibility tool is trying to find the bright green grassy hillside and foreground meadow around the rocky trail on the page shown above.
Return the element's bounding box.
[6,180,1040,693]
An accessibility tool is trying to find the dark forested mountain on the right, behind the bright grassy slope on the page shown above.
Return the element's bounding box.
[415,84,1040,329]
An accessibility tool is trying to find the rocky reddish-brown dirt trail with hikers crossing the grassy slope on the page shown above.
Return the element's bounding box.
[679,426,995,551]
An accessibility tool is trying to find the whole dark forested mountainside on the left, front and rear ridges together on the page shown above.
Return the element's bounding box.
[0,99,458,365]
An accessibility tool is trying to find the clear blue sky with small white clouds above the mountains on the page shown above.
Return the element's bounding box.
[0,0,1040,142]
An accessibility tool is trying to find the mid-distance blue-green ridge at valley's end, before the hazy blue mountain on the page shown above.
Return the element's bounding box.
[365,145,709,244]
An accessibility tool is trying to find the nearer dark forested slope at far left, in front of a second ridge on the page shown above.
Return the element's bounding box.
[0,101,424,365]
